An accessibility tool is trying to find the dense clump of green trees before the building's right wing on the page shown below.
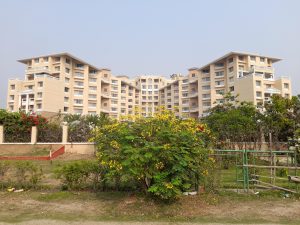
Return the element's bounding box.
[202,94,300,148]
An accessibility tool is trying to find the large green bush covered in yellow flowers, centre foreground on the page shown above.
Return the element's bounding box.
[93,109,213,200]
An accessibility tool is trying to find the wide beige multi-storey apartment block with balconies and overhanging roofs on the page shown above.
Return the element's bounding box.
[7,52,291,119]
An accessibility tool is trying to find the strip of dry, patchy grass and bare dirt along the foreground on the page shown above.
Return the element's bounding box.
[0,191,300,224]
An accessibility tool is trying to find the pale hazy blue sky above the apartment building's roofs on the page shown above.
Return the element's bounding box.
[0,0,300,108]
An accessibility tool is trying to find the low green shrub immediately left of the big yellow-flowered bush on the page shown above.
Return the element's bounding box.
[55,160,102,190]
